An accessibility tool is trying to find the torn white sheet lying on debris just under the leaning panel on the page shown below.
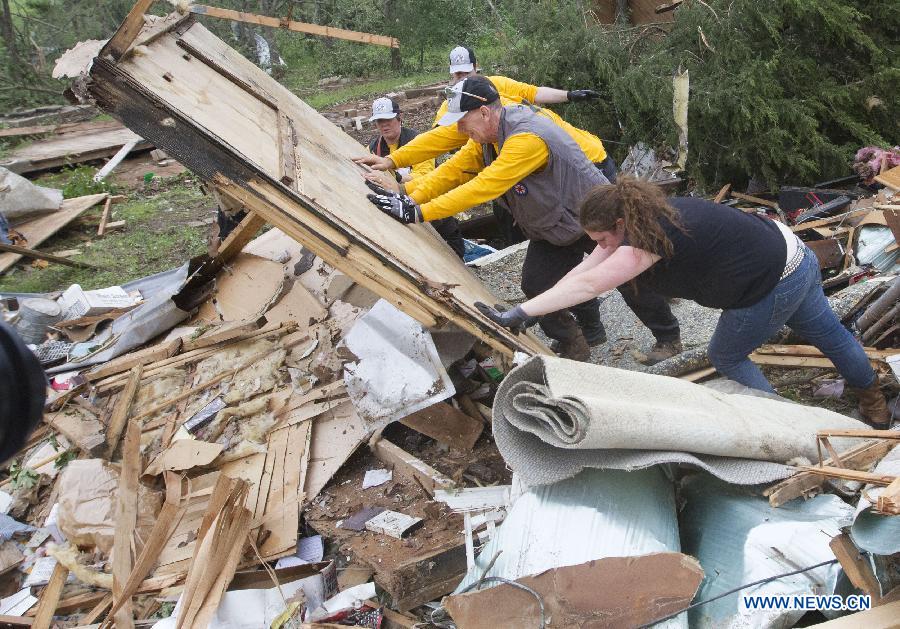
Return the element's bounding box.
[338,299,456,425]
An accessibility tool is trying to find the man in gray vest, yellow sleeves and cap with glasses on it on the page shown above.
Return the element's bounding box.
[369,76,680,360]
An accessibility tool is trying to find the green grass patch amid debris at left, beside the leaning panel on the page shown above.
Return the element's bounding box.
[0,177,214,293]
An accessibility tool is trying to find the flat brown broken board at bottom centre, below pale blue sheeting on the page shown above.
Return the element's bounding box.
[443,553,703,629]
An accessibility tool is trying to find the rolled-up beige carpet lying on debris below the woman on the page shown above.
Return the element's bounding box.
[493,356,866,485]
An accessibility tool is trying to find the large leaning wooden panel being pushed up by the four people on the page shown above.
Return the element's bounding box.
[90,13,548,354]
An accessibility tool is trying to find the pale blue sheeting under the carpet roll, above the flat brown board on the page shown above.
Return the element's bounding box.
[455,467,687,627]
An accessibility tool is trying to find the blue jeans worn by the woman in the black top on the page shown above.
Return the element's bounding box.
[709,247,875,393]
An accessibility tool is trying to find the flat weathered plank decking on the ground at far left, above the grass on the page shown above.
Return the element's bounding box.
[0,125,150,175]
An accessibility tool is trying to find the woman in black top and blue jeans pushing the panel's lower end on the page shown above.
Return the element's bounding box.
[476,178,891,428]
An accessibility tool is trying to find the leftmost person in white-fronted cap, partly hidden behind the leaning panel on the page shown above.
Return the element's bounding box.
[369,96,465,258]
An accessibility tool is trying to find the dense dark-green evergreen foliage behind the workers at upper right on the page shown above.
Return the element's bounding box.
[507,0,900,187]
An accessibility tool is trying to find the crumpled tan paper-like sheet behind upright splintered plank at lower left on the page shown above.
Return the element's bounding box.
[59,459,162,553]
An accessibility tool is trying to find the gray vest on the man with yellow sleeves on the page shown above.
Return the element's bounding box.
[482,105,609,245]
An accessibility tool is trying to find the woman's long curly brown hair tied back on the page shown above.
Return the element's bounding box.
[581,176,684,258]
